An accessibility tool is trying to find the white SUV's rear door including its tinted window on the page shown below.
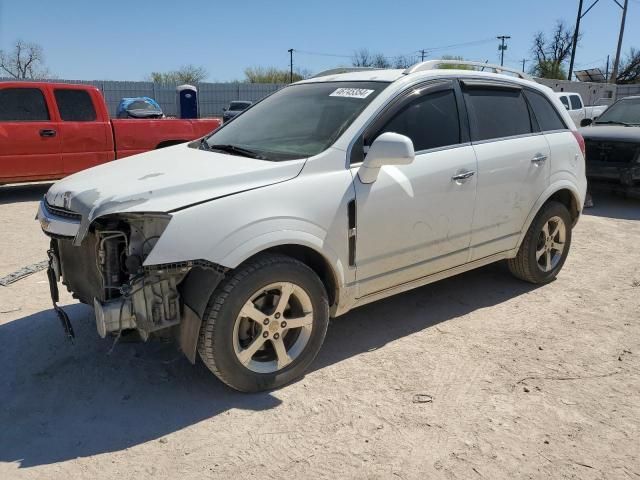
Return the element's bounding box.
[463,80,550,260]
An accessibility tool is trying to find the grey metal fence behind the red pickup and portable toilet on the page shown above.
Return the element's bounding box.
[0,78,286,117]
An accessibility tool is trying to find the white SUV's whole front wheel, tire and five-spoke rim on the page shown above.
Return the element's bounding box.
[198,254,329,392]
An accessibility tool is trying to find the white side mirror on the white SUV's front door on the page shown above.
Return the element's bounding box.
[358,132,416,183]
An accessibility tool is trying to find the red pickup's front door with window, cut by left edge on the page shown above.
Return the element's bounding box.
[0,84,62,182]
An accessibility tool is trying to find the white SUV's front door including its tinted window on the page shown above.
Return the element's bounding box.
[353,81,477,296]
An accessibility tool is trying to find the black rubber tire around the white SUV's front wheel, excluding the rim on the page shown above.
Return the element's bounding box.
[198,254,329,392]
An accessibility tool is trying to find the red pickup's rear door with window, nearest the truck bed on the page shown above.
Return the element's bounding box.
[53,87,115,175]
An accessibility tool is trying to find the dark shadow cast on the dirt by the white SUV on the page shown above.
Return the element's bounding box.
[0,265,535,468]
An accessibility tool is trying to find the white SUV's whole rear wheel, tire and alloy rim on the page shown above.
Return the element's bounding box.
[507,202,572,284]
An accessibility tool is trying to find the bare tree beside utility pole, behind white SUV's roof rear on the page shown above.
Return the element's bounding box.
[531,20,580,80]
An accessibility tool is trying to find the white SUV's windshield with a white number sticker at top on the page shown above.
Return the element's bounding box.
[200,82,388,161]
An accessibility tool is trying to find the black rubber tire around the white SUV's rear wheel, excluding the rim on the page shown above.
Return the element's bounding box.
[507,201,572,284]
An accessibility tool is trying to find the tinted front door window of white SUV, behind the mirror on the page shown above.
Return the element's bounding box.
[378,90,460,152]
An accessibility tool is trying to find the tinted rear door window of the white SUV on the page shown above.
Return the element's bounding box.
[464,87,532,141]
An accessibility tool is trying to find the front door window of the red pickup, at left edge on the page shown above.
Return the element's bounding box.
[0,88,49,122]
